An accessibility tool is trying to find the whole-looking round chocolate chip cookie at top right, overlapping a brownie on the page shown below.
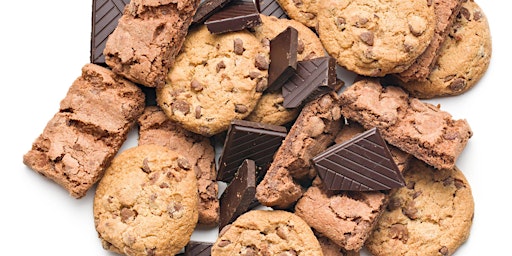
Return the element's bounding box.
[317,0,436,77]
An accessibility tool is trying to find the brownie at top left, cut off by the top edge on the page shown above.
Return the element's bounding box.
[103,0,200,87]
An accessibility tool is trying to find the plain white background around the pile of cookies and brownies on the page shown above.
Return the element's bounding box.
[0,0,512,256]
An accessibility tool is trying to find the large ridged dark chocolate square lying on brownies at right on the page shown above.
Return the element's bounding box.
[313,128,405,191]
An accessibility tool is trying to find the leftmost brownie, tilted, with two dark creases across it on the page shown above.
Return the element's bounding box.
[23,64,145,198]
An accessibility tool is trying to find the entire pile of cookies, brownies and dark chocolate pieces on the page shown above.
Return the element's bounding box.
[23,0,492,256]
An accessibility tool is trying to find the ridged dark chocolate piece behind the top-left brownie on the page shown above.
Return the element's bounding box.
[90,0,130,66]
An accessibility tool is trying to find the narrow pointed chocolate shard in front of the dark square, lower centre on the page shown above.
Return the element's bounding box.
[219,159,256,230]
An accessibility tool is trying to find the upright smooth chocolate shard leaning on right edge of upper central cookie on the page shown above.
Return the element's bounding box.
[267,27,299,91]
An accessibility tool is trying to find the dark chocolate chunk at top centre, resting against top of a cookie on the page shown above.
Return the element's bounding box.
[204,0,261,34]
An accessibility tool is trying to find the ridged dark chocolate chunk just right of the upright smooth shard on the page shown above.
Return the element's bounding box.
[282,57,336,108]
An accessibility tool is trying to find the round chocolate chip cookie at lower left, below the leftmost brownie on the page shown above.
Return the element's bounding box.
[93,145,199,255]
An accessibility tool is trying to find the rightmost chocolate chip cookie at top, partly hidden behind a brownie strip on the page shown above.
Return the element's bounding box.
[400,1,492,99]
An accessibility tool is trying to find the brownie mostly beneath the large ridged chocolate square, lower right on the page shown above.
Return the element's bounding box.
[295,120,411,253]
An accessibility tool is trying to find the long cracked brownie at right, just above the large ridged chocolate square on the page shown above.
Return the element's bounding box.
[340,78,473,169]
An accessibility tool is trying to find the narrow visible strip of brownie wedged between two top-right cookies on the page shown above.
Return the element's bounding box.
[397,0,462,82]
